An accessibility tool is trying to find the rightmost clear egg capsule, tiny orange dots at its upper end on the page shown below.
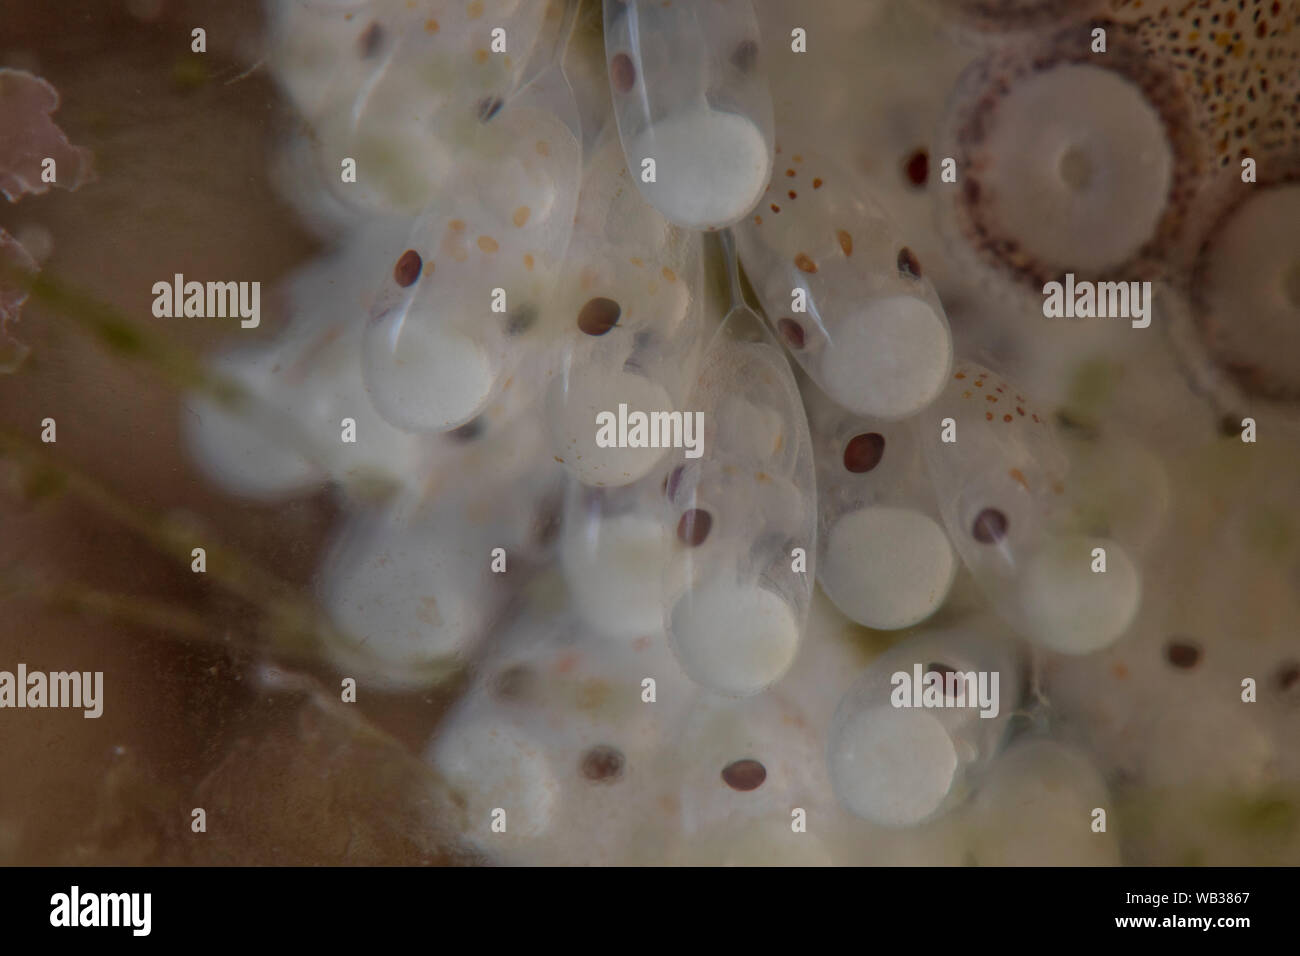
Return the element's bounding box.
[915,362,1141,654]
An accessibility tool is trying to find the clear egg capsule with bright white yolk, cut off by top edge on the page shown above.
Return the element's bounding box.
[605,0,772,229]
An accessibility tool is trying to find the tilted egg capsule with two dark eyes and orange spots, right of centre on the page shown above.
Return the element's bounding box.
[736,153,953,419]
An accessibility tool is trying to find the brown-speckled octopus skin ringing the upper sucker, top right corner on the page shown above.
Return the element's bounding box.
[952,0,1300,290]
